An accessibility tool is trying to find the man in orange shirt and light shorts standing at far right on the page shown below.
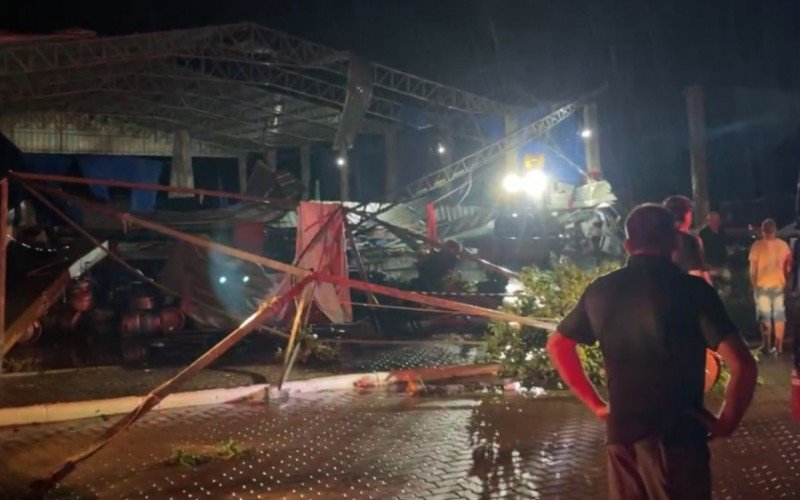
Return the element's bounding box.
[750,219,792,354]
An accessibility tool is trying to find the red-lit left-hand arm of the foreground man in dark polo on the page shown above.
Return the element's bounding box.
[547,332,608,420]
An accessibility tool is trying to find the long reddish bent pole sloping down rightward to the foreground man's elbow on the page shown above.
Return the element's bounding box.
[32,186,557,330]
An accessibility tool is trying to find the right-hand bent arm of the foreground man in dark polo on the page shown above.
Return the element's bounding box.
[704,335,758,437]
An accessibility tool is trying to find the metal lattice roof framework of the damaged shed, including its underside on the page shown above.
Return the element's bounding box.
[0,24,515,150]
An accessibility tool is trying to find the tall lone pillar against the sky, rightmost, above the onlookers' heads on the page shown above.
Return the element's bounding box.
[685,85,710,224]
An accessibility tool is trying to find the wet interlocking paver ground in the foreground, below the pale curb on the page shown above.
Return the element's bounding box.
[0,360,800,499]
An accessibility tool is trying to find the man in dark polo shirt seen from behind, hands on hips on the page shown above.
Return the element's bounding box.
[547,204,757,500]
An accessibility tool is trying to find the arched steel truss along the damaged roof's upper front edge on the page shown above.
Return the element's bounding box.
[0,24,517,133]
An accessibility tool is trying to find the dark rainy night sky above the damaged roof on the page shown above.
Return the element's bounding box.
[0,0,800,220]
